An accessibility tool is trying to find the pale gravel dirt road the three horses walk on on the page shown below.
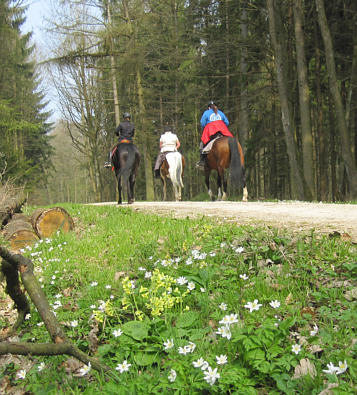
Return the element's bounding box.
[94,202,357,242]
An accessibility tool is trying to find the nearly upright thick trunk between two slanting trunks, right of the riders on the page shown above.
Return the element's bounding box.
[294,0,316,200]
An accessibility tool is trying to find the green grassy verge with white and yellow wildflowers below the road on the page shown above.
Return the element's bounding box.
[0,205,357,394]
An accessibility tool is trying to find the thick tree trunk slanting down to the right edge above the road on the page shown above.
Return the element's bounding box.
[315,0,357,199]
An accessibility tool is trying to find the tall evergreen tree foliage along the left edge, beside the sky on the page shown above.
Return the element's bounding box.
[0,1,51,187]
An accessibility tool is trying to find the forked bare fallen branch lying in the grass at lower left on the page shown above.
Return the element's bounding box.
[0,246,111,373]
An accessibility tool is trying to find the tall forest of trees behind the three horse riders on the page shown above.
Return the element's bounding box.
[0,0,357,204]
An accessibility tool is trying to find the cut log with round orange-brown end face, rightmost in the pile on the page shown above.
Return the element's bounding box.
[31,207,74,239]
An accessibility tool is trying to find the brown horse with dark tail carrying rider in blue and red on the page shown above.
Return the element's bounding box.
[204,136,248,202]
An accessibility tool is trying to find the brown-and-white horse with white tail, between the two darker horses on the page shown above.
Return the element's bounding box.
[160,152,185,201]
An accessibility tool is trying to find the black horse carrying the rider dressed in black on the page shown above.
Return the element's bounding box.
[112,143,140,204]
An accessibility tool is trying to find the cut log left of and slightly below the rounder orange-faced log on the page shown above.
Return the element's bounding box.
[4,220,39,251]
